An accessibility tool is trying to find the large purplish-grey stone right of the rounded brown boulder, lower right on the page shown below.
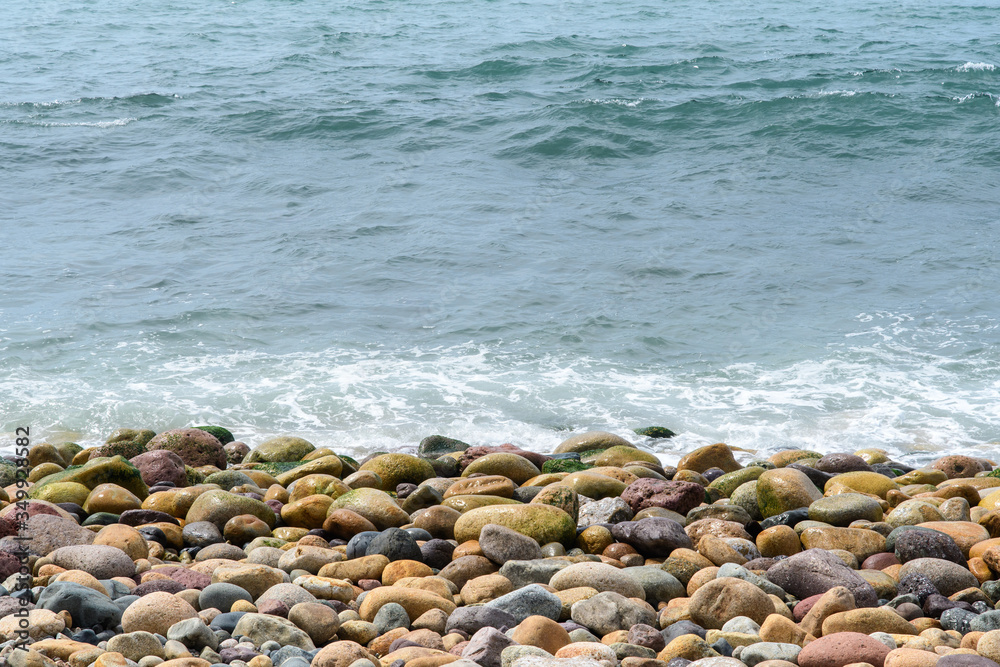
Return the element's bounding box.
[767,549,878,607]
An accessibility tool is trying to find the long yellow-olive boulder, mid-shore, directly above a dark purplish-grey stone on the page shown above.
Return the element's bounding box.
[455,503,576,546]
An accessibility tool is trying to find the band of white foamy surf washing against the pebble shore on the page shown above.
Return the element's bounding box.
[0,313,1000,462]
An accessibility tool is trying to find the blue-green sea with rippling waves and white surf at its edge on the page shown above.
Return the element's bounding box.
[0,0,1000,461]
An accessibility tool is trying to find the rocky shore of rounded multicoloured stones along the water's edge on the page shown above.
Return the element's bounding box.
[0,427,1000,667]
